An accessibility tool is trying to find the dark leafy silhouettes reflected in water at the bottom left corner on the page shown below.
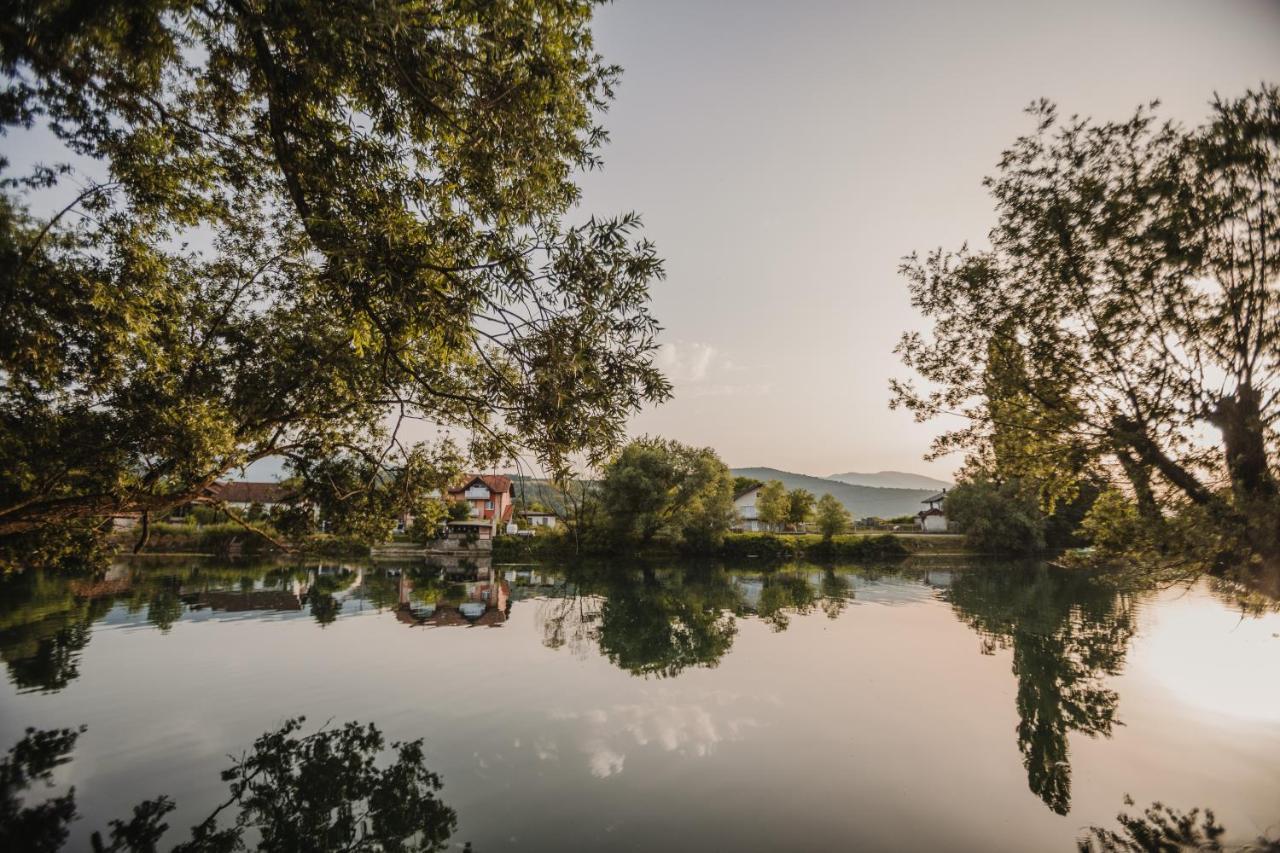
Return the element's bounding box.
[0,717,457,853]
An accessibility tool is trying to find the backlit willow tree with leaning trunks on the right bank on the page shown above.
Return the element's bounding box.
[895,86,1280,560]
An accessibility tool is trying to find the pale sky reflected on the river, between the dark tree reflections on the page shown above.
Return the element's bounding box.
[0,560,1280,850]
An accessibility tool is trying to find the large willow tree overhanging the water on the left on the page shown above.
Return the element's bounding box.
[0,0,669,550]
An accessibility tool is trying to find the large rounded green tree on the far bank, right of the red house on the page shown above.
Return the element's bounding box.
[600,438,733,551]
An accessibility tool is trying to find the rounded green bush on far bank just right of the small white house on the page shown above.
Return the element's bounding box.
[943,478,1044,553]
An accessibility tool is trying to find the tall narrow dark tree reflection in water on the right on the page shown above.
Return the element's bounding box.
[947,564,1133,815]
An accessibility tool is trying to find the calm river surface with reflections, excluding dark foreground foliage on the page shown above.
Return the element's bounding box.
[0,560,1280,850]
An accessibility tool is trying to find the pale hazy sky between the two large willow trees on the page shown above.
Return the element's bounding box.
[584,0,1280,476]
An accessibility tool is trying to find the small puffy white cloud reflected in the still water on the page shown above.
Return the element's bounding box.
[539,694,759,779]
